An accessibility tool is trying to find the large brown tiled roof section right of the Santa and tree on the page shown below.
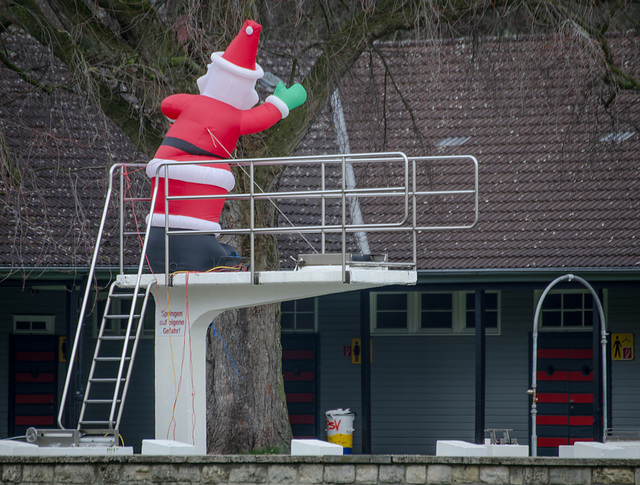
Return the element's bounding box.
[281,35,640,270]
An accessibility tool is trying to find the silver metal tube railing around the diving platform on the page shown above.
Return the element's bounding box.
[141,152,478,284]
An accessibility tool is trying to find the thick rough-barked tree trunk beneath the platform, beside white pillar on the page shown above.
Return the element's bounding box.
[207,304,291,454]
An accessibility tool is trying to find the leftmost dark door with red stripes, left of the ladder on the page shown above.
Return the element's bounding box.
[9,335,58,436]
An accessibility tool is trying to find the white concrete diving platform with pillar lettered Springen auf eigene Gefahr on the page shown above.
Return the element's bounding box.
[131,266,417,455]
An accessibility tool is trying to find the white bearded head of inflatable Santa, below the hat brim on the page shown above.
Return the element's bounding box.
[198,53,263,109]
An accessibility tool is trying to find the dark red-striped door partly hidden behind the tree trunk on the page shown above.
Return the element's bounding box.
[282,334,317,438]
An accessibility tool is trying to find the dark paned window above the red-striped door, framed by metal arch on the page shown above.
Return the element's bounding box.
[536,290,604,330]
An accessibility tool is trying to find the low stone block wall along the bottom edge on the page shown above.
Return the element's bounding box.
[0,455,640,485]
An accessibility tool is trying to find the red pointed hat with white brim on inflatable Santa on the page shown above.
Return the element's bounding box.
[211,20,264,79]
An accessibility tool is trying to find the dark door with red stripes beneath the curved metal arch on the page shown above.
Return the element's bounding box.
[536,332,595,456]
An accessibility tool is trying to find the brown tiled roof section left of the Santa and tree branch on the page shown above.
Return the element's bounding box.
[0,29,146,272]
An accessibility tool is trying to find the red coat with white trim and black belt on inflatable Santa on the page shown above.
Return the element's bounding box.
[147,94,282,231]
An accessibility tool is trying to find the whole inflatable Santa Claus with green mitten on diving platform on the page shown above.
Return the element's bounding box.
[147,20,307,271]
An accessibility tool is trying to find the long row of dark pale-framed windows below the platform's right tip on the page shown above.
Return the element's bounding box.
[371,291,500,335]
